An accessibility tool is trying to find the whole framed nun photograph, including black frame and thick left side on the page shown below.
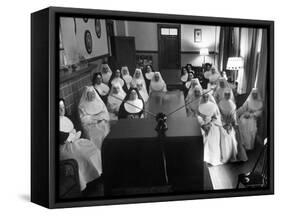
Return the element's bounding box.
[31,7,274,208]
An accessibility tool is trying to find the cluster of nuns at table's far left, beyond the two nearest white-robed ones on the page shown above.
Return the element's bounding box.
[91,64,167,120]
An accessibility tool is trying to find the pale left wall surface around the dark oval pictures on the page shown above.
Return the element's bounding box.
[60,17,108,64]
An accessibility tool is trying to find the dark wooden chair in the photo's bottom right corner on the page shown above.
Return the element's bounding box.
[236,138,268,189]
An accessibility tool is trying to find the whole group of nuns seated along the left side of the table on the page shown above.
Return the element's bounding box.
[59,64,167,190]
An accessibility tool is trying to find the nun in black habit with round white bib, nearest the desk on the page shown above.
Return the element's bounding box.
[118,88,144,119]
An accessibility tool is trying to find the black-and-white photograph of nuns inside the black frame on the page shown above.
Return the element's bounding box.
[56,16,273,201]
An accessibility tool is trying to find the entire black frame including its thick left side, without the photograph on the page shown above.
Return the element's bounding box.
[31,7,274,208]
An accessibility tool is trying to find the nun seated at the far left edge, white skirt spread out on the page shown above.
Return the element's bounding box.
[59,99,102,191]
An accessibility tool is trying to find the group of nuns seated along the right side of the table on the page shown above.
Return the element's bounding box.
[182,62,263,166]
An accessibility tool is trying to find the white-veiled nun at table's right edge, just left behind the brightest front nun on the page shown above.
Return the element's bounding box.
[186,85,202,117]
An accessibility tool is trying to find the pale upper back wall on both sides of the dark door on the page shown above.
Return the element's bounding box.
[124,21,220,69]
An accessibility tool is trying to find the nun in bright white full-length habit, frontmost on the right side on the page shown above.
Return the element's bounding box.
[197,90,222,166]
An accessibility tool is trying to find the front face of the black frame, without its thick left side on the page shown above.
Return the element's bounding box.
[33,7,274,208]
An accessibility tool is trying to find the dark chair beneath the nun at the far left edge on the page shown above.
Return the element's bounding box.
[59,159,81,199]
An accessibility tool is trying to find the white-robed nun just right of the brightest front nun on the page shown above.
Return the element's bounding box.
[218,89,238,163]
